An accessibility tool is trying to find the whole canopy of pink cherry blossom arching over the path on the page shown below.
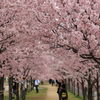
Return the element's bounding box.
[0,0,100,100]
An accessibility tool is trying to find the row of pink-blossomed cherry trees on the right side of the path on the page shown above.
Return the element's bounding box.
[48,0,100,100]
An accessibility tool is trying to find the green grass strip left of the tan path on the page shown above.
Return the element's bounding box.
[4,86,47,100]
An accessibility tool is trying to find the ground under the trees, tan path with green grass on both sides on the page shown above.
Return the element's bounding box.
[5,84,82,100]
